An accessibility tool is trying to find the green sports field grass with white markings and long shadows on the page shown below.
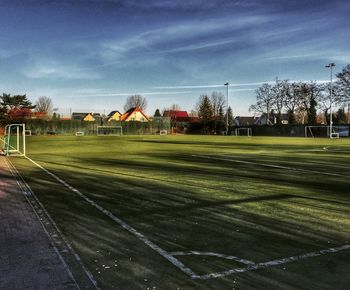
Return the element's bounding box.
[6,136,350,289]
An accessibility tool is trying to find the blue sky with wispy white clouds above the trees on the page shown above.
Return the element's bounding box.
[0,0,350,116]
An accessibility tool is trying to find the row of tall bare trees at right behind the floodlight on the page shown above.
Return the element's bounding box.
[249,64,350,125]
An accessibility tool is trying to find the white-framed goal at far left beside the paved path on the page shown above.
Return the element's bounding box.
[3,124,26,156]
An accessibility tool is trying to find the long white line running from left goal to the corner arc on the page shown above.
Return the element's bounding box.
[25,156,198,279]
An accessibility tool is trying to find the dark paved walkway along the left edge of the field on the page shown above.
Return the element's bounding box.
[0,156,79,290]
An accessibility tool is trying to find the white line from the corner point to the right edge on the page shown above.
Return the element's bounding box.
[196,245,350,280]
